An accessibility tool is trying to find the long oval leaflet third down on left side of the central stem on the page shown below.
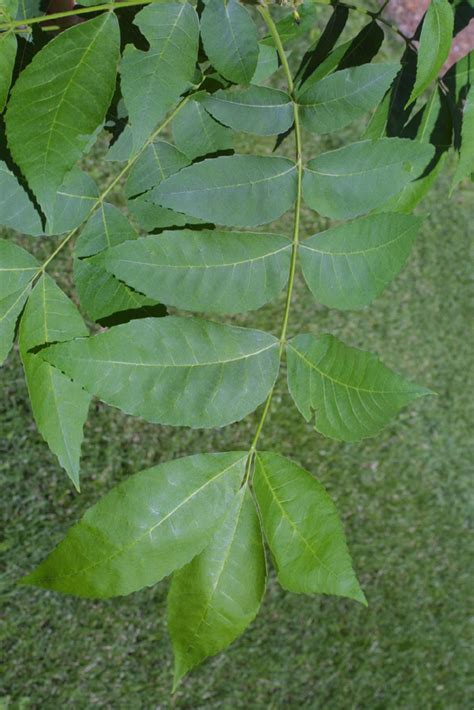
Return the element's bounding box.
[105,230,291,313]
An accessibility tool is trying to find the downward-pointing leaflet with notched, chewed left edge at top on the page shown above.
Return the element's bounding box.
[120,3,199,150]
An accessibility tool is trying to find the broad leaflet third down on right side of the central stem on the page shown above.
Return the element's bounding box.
[300,213,423,309]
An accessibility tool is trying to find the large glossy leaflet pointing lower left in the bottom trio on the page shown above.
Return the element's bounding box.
[23,451,246,598]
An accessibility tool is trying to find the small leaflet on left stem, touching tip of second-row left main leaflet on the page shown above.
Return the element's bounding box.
[125,140,190,197]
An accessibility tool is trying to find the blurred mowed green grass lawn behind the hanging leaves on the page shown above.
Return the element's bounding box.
[0,55,474,710]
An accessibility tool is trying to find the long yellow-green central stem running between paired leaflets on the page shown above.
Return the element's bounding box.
[244,5,303,482]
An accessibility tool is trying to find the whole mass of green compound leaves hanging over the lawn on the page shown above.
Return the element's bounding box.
[0,0,474,683]
